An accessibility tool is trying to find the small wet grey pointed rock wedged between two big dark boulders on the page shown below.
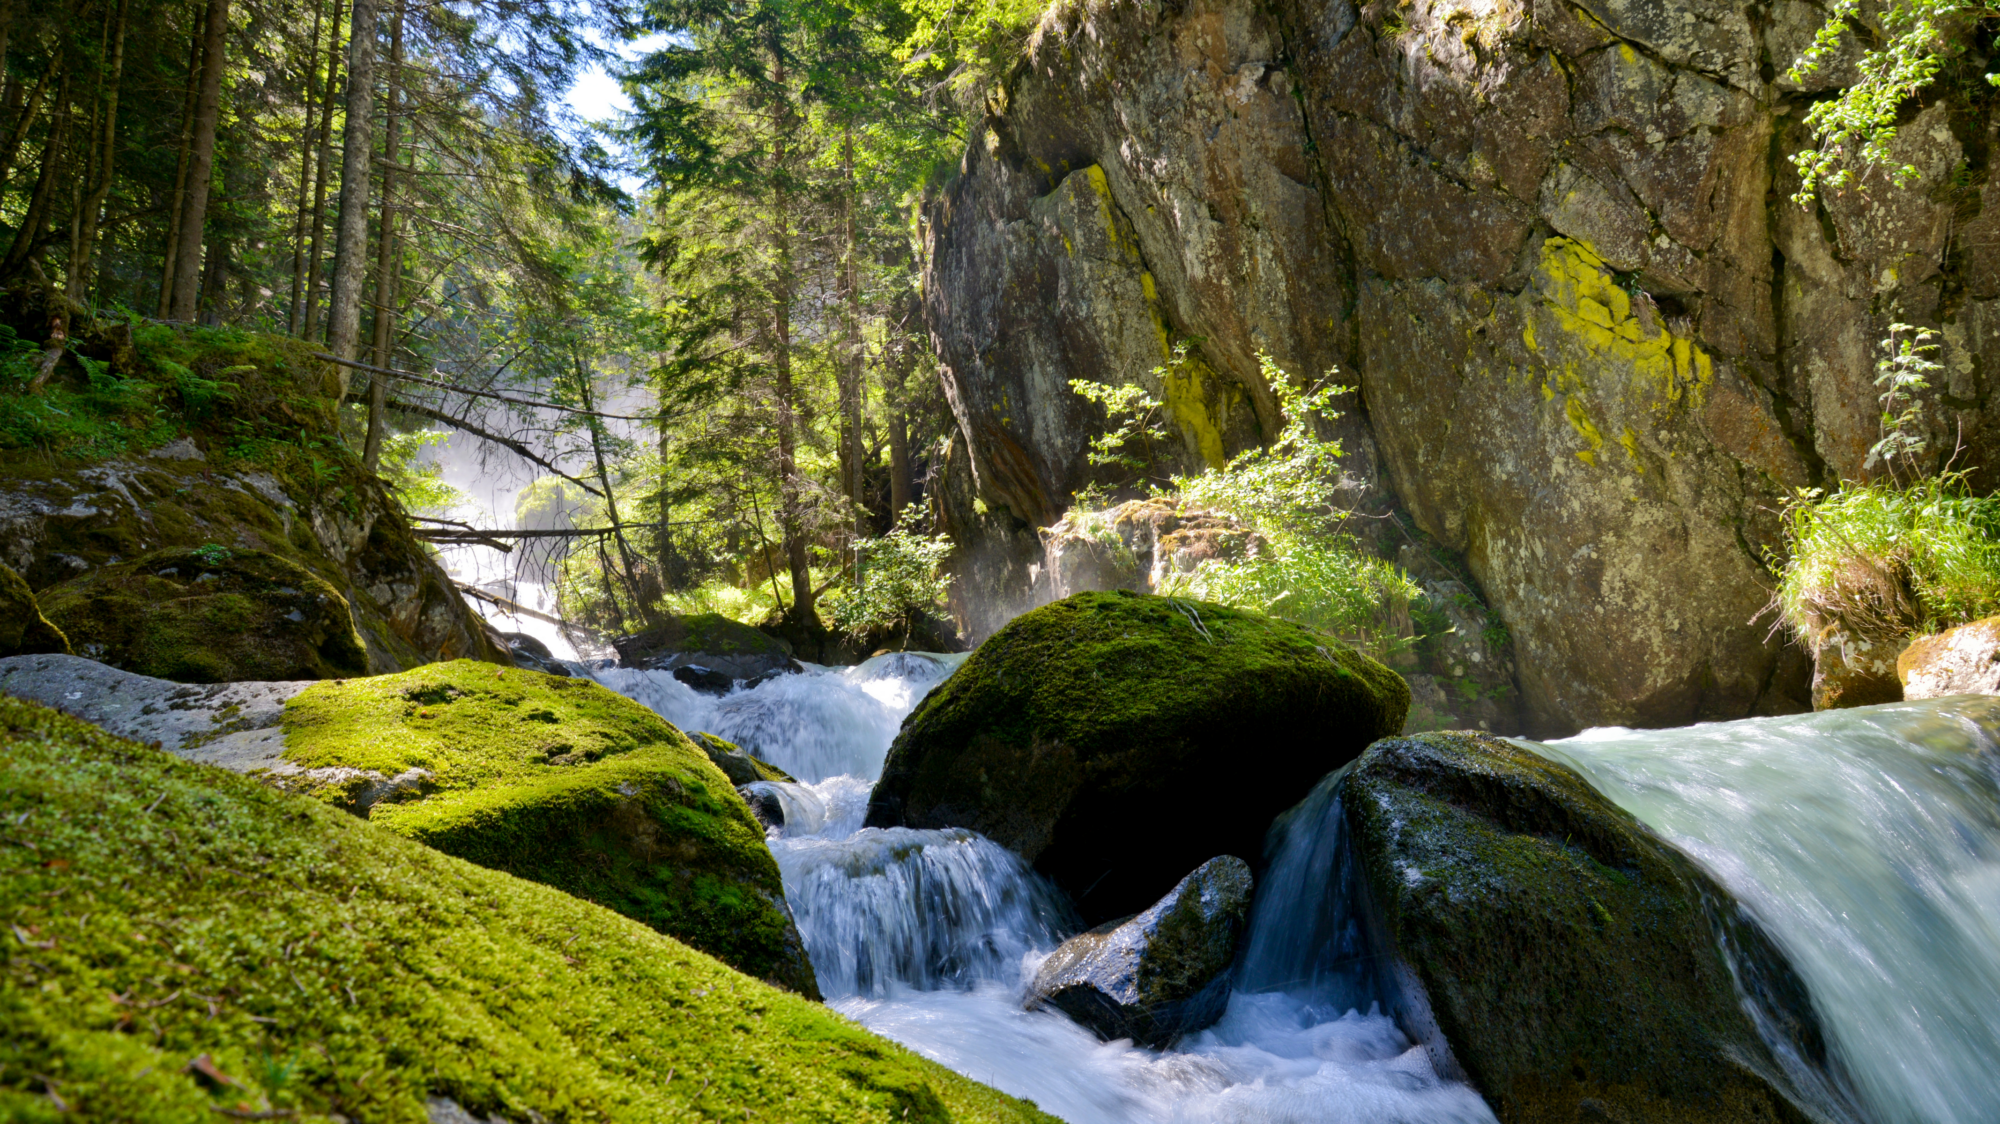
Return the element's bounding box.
[1026,854,1250,1048]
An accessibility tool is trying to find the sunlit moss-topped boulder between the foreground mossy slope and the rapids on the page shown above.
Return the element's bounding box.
[284,660,818,998]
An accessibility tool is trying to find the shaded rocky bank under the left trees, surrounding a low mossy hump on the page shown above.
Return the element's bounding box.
[0,438,504,668]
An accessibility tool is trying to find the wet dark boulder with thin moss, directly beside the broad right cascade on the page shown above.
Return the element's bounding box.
[1338,734,1854,1124]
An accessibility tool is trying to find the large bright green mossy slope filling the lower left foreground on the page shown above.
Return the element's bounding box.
[0,692,1054,1124]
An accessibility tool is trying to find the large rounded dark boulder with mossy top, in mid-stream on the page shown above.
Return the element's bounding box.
[868,590,1410,924]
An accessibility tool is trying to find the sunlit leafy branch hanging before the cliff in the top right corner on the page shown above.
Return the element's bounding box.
[1786,0,2000,206]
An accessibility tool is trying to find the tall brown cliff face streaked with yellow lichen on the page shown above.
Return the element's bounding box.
[926,0,2000,734]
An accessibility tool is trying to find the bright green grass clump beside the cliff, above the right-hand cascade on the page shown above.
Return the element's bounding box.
[1772,472,2000,652]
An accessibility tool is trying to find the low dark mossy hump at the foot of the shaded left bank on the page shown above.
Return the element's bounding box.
[40,546,368,682]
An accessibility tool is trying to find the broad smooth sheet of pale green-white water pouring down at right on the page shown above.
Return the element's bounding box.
[1524,696,2000,1124]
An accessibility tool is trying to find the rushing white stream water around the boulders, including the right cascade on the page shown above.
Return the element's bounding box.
[590,654,2000,1124]
